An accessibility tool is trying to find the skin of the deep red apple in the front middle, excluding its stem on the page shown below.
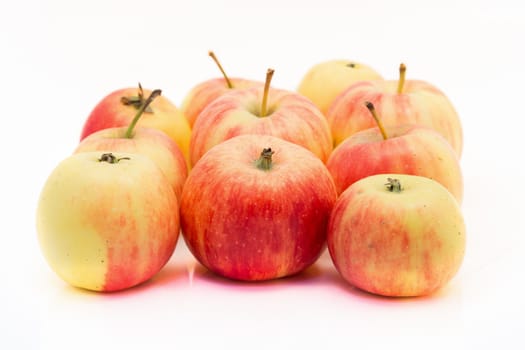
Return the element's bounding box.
[180,135,337,281]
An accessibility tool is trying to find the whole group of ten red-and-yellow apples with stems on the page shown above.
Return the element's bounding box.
[37,52,465,296]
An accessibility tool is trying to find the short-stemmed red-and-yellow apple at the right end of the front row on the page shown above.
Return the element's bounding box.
[327,174,466,297]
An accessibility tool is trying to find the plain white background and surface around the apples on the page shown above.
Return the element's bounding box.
[0,0,525,349]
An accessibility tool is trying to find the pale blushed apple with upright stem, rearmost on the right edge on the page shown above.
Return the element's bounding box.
[326,64,463,158]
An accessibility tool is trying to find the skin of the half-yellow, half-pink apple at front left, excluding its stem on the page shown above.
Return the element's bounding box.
[36,152,180,292]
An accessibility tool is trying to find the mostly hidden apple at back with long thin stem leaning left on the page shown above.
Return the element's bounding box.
[181,51,263,127]
